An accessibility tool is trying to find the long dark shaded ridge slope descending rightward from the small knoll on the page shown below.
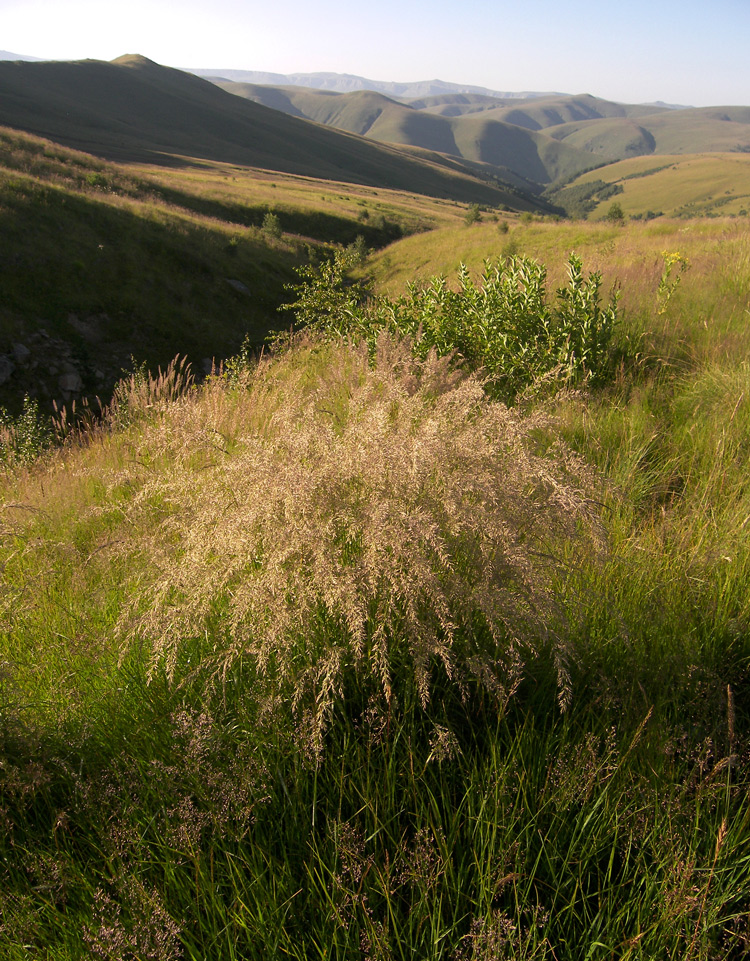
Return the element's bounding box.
[0,56,524,204]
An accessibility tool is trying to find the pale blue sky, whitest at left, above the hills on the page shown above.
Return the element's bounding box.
[0,0,750,106]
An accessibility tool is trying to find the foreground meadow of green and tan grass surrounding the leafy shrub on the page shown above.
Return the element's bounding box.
[0,199,750,961]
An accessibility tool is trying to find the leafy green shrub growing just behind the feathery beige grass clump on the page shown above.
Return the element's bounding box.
[289,251,618,400]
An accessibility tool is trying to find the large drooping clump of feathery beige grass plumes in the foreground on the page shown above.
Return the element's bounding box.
[114,335,604,752]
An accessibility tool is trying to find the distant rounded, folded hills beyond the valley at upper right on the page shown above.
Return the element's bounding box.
[216,72,750,184]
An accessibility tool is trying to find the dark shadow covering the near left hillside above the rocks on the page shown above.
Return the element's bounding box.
[0,179,306,409]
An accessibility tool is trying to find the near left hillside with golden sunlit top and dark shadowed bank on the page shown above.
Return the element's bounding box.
[0,128,494,410]
